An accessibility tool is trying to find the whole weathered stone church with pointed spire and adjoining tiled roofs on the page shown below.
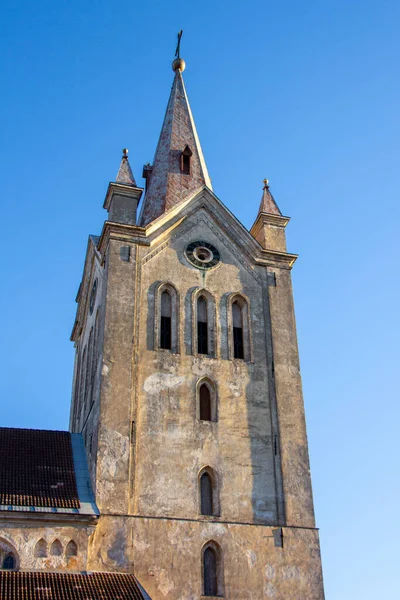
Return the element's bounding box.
[0,51,324,600]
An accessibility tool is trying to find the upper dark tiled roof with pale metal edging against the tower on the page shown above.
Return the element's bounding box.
[0,427,80,509]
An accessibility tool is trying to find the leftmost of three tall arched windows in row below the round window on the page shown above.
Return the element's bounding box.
[154,283,179,354]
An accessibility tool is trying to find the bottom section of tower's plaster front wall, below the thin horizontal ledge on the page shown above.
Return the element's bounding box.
[88,517,324,600]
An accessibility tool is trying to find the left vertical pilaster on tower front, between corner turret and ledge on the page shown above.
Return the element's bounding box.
[96,239,135,514]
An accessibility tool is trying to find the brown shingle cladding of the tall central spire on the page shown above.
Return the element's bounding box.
[141,68,212,225]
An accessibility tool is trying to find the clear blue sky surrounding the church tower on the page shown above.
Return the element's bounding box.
[0,0,400,600]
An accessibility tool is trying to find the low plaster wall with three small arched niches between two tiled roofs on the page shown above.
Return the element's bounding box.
[0,520,93,571]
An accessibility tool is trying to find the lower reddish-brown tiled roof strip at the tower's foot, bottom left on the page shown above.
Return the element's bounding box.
[0,571,144,600]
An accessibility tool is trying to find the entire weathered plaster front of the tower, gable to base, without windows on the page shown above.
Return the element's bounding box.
[76,196,323,600]
